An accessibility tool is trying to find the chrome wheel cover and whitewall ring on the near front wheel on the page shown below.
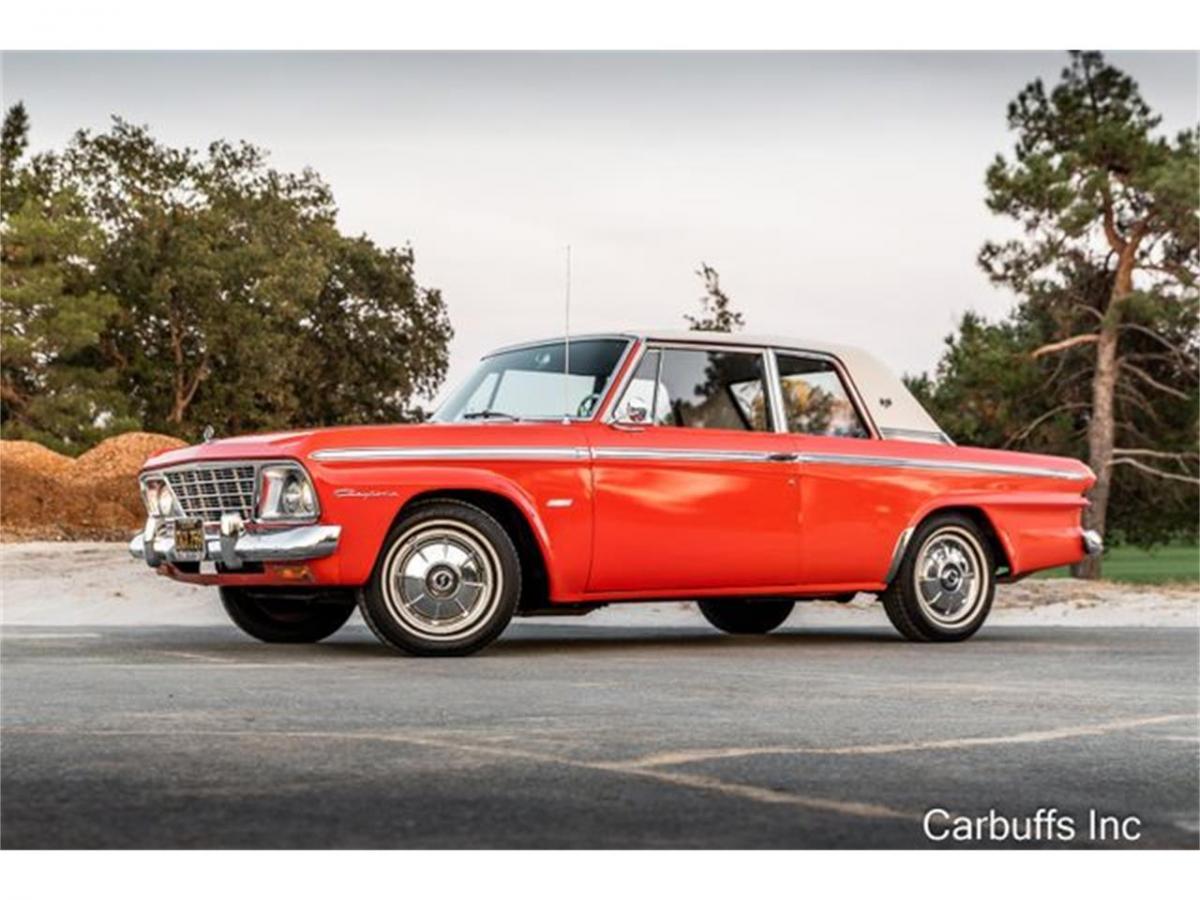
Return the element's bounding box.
[383,518,504,641]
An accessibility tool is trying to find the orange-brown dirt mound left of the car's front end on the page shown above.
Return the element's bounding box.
[0,432,184,541]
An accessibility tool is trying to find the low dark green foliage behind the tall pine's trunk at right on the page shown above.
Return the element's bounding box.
[907,259,1200,556]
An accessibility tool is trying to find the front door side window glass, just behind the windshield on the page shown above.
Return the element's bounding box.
[638,348,774,431]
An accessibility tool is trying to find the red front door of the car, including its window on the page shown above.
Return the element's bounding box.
[588,344,799,595]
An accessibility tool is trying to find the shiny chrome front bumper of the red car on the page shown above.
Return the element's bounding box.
[130,518,342,569]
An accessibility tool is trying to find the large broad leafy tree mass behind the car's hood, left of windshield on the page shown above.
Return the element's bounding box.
[57,119,450,438]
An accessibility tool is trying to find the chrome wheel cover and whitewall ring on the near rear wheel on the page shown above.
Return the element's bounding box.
[913,526,991,628]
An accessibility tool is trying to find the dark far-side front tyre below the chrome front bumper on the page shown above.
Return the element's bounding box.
[221,588,354,643]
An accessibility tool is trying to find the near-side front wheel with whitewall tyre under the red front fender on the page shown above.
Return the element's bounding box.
[359,500,521,656]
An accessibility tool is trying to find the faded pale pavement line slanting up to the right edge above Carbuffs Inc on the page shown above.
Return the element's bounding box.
[620,713,1196,768]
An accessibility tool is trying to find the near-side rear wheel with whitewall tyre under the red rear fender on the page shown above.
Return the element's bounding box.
[880,515,996,642]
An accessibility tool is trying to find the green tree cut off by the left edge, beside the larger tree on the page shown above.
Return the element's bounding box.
[0,103,137,452]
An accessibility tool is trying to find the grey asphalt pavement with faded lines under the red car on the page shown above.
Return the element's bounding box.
[0,617,1200,848]
